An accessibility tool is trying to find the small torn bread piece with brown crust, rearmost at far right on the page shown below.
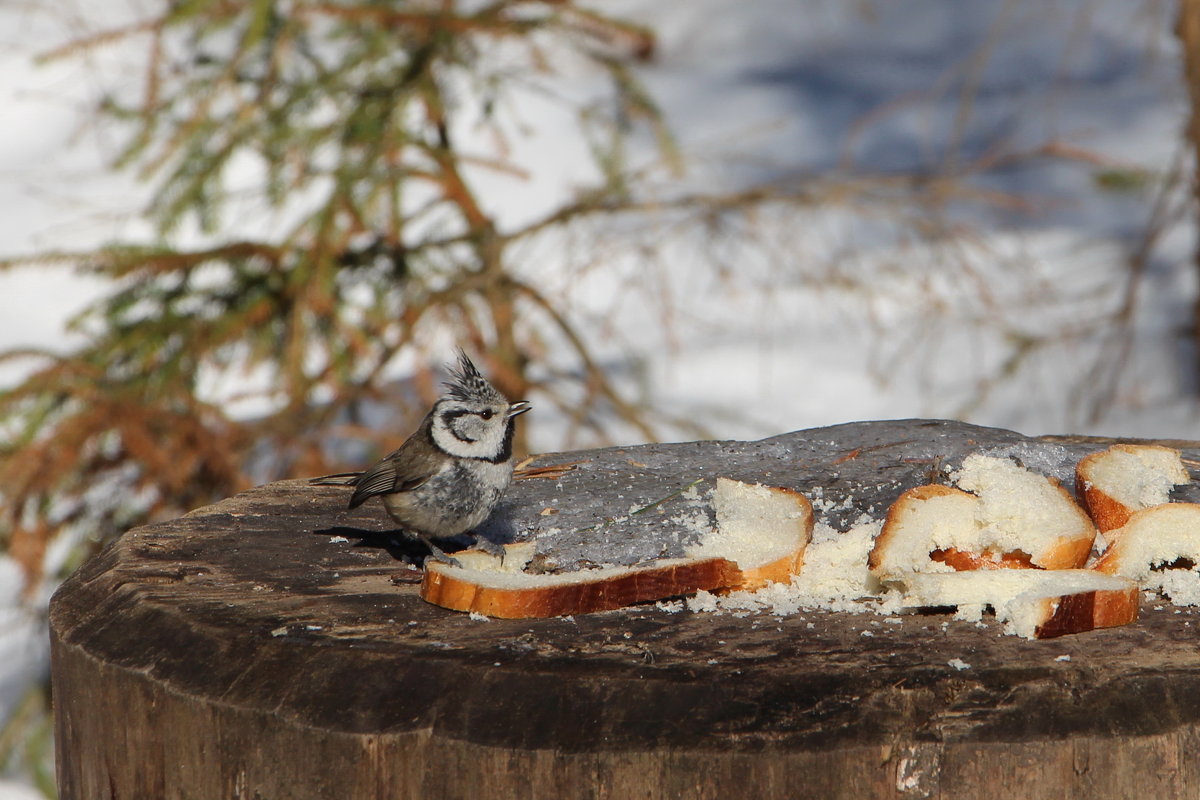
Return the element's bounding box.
[1075,445,1192,540]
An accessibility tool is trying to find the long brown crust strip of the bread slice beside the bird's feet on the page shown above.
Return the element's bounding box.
[420,558,742,619]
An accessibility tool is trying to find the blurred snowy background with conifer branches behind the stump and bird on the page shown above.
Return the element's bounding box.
[0,0,1200,798]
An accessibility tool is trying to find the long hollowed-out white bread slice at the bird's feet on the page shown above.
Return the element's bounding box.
[421,479,812,619]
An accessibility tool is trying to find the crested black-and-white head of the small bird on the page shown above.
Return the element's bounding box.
[432,351,512,463]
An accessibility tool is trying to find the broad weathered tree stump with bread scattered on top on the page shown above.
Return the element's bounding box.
[50,421,1200,800]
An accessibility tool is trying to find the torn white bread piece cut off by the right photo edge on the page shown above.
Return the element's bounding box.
[1092,503,1200,606]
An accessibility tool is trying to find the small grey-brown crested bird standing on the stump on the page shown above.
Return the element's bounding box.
[313,351,529,563]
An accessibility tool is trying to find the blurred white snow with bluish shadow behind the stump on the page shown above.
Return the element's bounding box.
[0,0,1200,798]
